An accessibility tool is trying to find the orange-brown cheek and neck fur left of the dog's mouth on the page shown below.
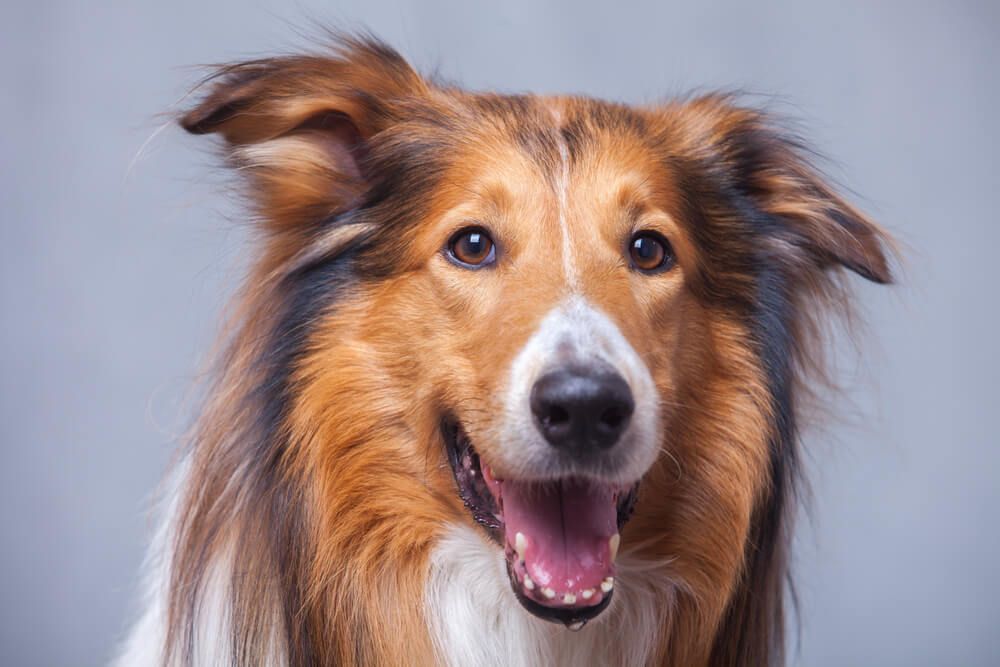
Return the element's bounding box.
[289,283,452,664]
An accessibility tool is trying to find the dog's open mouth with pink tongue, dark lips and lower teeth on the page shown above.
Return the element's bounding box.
[441,420,639,630]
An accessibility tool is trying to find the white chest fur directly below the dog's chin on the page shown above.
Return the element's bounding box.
[425,525,673,667]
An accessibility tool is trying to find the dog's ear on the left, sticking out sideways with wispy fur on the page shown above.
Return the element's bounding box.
[180,38,427,232]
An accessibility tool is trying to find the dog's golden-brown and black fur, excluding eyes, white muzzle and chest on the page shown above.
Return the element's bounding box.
[152,34,890,666]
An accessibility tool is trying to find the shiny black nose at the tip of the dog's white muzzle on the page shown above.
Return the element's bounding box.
[531,367,635,452]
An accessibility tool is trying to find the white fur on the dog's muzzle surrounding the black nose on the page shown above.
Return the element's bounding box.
[494,296,659,483]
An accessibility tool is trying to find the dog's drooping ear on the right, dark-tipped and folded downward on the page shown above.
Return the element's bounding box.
[668,95,893,283]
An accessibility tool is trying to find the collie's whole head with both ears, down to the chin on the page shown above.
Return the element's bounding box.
[182,35,889,648]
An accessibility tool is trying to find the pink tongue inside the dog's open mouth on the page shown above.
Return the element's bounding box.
[499,480,618,596]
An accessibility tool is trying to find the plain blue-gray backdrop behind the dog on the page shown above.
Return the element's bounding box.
[0,0,1000,666]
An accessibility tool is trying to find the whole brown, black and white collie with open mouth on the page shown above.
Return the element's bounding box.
[120,37,892,667]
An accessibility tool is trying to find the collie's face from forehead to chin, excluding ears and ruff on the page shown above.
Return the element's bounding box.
[386,112,703,623]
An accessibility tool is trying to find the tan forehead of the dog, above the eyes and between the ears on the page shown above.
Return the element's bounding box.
[444,95,664,223]
